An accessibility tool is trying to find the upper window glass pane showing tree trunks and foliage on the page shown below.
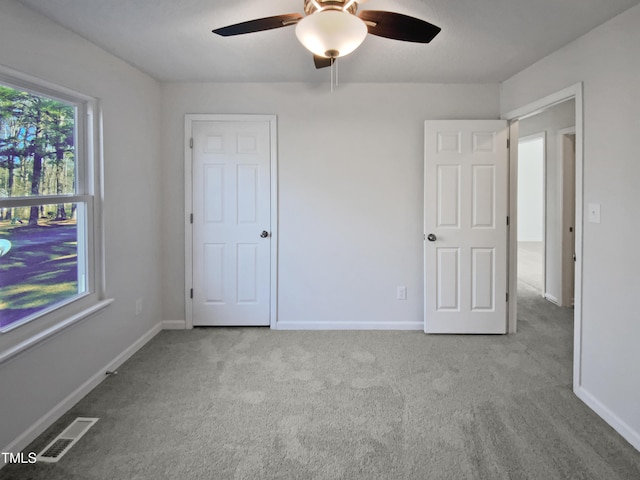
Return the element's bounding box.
[0,85,77,198]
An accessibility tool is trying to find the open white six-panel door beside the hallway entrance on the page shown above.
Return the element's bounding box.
[424,120,508,333]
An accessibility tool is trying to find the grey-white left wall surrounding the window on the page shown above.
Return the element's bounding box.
[0,0,162,451]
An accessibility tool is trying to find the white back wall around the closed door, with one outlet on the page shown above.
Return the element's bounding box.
[162,82,499,329]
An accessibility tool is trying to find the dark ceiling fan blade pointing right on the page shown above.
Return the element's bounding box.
[358,10,441,43]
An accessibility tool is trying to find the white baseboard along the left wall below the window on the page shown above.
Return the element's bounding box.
[0,323,162,460]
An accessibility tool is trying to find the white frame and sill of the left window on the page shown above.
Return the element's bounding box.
[0,66,113,364]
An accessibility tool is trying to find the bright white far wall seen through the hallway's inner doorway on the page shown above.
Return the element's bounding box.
[518,137,544,242]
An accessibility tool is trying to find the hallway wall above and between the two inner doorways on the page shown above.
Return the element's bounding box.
[518,100,576,304]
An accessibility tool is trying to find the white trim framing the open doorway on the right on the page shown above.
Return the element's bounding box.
[502,82,584,392]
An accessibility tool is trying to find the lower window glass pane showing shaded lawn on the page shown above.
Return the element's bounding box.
[0,203,87,330]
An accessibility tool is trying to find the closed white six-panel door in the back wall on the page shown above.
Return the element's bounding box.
[191,120,272,326]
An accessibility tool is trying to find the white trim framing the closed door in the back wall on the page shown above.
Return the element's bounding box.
[184,113,278,329]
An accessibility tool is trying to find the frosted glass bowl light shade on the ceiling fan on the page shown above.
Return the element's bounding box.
[296,10,367,57]
